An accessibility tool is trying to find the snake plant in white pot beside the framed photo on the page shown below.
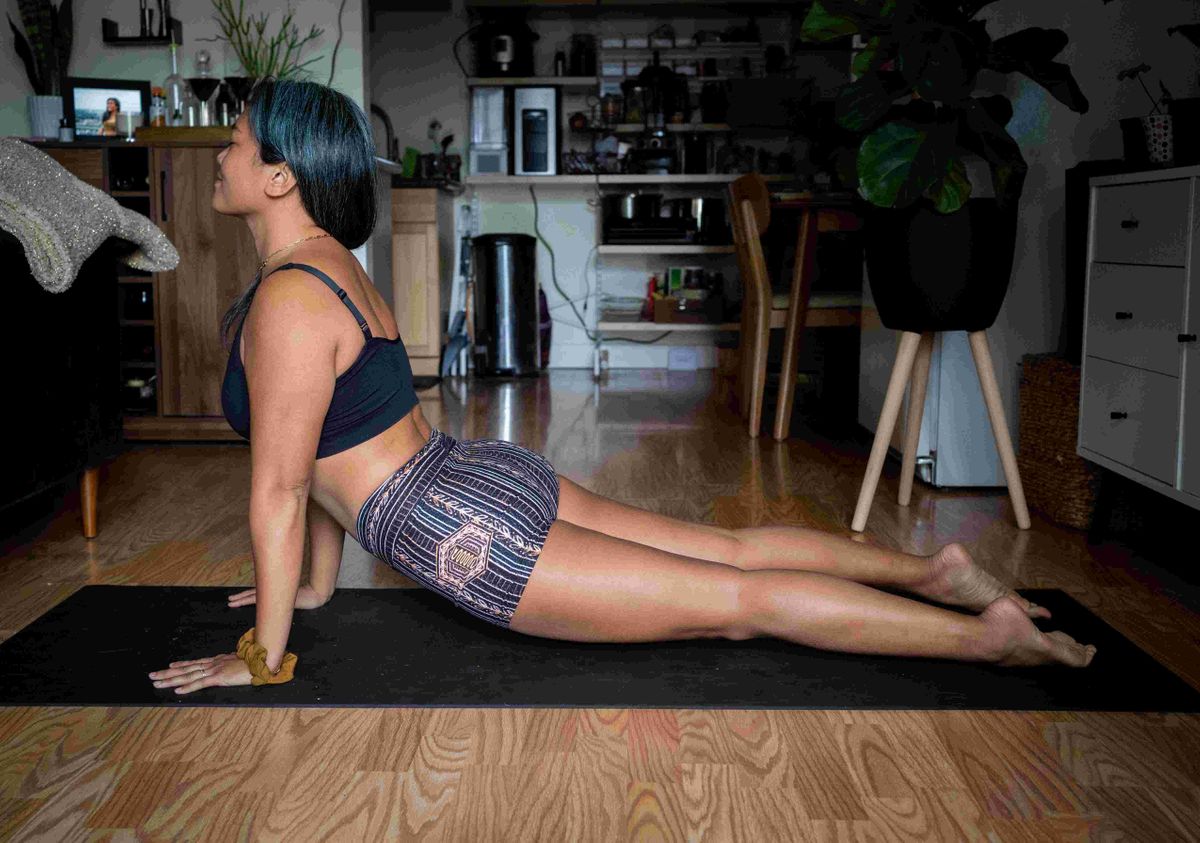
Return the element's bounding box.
[8,0,72,138]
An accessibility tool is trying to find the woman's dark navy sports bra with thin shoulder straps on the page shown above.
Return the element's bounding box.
[221,263,418,459]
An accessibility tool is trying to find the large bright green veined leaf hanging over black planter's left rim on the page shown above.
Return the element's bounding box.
[858,121,953,208]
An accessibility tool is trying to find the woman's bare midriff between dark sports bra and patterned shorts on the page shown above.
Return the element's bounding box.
[308,405,431,539]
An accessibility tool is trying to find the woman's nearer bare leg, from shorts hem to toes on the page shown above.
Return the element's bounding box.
[511,520,1094,666]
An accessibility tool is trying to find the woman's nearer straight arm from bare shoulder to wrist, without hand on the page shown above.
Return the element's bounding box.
[245,270,336,671]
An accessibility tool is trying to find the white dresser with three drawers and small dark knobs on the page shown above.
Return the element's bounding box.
[1078,167,1200,509]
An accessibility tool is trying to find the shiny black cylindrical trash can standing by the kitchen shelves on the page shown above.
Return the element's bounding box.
[472,234,541,376]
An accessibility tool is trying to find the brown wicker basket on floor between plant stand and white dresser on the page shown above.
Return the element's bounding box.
[1016,354,1100,530]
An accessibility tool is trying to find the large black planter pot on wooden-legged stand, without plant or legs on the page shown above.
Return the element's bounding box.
[862,199,1016,334]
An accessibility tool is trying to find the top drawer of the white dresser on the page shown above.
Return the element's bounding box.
[1092,179,1192,267]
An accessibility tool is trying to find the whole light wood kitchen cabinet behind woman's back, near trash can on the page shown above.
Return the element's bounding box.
[391,187,454,375]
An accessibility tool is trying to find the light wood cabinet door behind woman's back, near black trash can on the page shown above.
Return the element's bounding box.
[391,222,442,357]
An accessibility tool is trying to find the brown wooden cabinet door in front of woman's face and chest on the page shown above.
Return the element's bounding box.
[155,147,258,415]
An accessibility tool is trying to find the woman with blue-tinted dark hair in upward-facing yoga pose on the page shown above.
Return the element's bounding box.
[150,82,1094,693]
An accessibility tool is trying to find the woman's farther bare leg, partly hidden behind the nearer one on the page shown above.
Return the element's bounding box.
[558,474,1050,617]
